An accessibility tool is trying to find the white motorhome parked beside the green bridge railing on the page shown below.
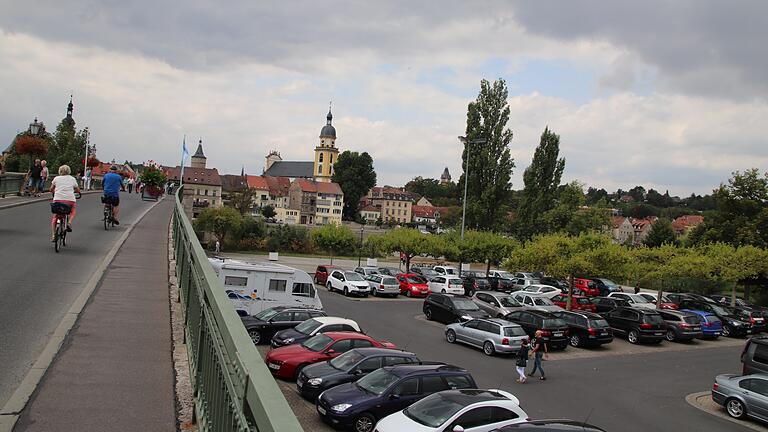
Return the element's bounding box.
[208,258,323,315]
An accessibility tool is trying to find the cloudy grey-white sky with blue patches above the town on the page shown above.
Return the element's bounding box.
[0,0,768,195]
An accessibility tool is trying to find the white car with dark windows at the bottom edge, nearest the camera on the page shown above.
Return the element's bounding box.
[376,389,528,432]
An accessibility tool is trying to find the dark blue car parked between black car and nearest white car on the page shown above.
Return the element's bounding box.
[316,365,477,432]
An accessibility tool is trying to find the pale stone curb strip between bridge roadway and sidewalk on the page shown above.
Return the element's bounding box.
[0,199,160,432]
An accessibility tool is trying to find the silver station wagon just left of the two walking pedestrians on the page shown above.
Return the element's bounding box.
[445,318,528,356]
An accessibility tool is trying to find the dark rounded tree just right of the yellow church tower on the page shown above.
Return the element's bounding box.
[332,150,376,220]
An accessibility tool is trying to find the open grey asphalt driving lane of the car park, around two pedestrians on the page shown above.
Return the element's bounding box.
[318,287,748,432]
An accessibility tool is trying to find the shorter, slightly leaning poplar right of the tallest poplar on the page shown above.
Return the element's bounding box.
[517,127,565,238]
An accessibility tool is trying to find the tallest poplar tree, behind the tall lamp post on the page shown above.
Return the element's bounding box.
[458,79,515,230]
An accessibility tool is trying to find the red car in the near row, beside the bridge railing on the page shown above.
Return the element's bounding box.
[264,332,395,380]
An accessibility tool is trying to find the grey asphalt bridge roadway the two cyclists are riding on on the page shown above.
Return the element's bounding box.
[0,194,152,406]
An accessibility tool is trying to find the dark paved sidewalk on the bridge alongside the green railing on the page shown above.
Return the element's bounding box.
[14,200,176,432]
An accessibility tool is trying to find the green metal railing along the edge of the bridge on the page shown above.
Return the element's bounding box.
[173,190,303,432]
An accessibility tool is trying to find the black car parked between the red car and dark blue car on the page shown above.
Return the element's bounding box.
[296,348,420,402]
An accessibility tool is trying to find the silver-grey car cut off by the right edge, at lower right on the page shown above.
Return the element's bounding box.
[712,374,768,422]
